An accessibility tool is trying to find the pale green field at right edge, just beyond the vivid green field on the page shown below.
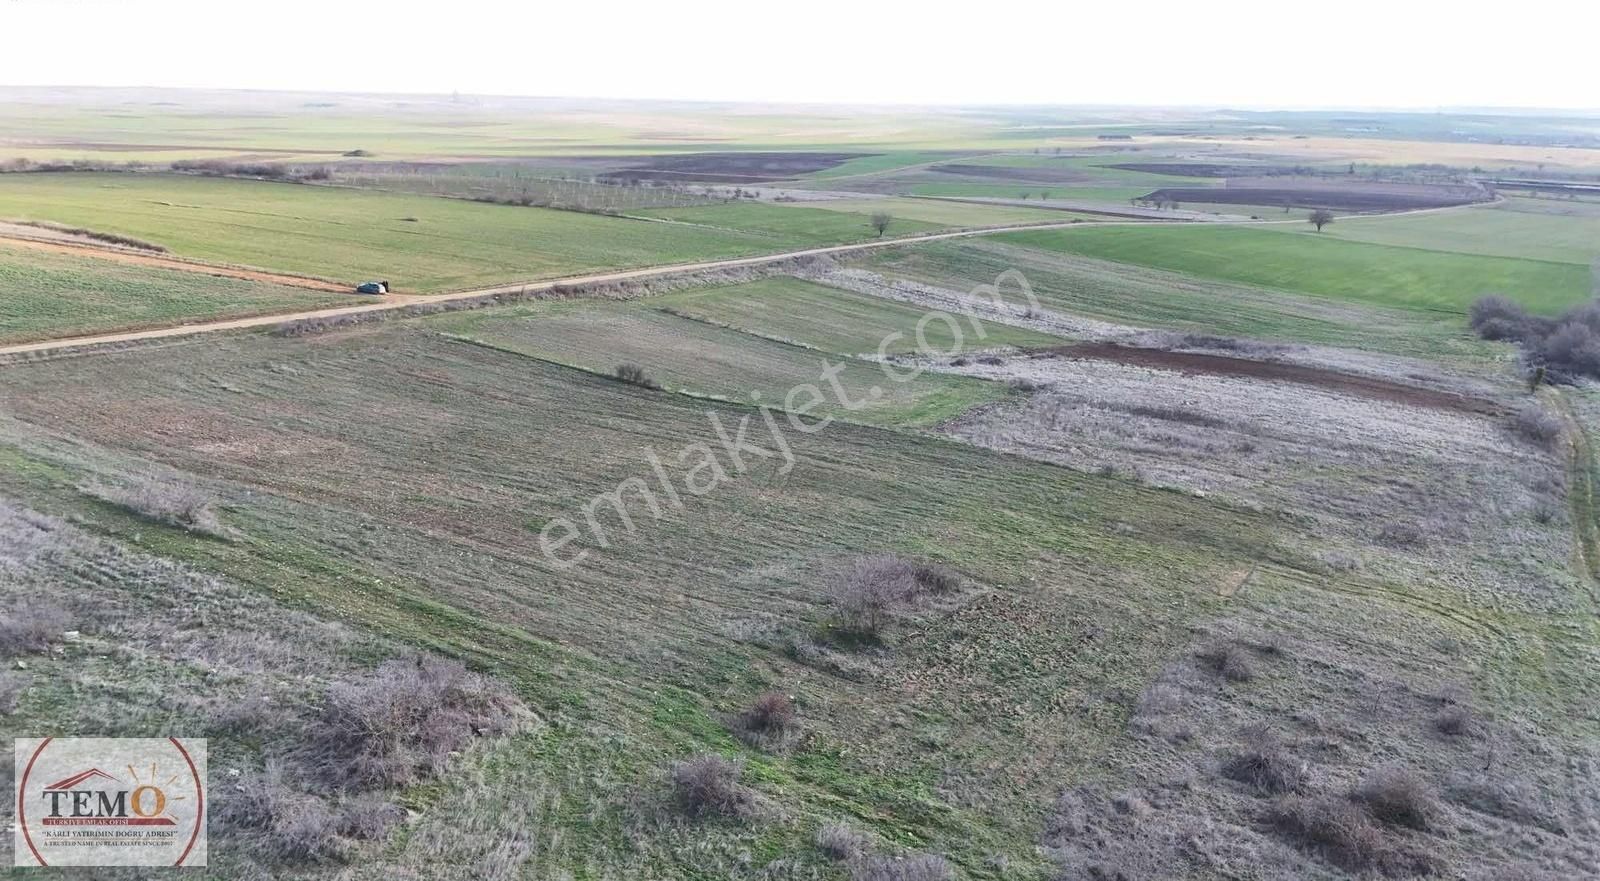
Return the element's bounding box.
[1325,198,1600,265]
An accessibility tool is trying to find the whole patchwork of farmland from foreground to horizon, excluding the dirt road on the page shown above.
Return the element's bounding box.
[0,90,1600,881]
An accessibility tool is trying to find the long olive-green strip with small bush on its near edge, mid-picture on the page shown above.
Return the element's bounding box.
[435,295,1008,427]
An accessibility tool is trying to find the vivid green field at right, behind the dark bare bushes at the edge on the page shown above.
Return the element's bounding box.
[997,224,1590,313]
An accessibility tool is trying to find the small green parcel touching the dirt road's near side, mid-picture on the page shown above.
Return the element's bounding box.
[651,277,1061,355]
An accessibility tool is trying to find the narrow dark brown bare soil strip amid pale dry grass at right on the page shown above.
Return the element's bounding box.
[1051,342,1506,416]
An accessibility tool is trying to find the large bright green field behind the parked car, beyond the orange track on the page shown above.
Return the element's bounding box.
[0,174,844,291]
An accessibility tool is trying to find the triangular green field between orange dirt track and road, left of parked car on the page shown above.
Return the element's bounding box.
[0,243,352,342]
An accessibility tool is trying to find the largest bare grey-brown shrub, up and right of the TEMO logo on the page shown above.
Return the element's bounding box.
[298,657,522,790]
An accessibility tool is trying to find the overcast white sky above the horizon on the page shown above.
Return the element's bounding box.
[0,0,1600,109]
